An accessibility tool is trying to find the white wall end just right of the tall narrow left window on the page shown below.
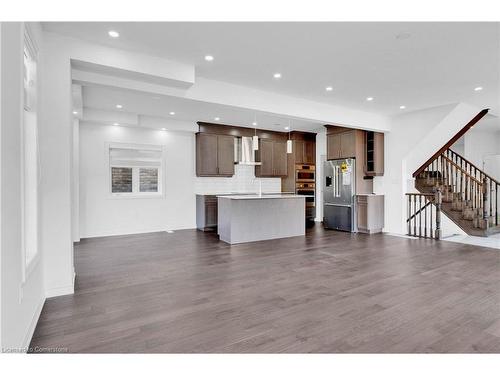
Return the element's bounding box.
[40,33,74,297]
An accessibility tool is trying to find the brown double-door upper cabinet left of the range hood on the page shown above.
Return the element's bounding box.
[196,133,234,177]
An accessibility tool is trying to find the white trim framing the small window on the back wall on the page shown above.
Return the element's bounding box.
[104,142,166,199]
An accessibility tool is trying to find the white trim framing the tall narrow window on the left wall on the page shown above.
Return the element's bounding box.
[20,23,41,284]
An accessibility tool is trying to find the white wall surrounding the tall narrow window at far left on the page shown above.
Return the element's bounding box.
[0,23,45,349]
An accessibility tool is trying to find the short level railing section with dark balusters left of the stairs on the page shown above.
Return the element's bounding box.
[406,189,442,240]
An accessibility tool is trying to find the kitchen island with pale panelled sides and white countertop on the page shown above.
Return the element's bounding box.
[217,194,305,244]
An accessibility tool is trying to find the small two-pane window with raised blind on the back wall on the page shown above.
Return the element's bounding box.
[109,144,163,196]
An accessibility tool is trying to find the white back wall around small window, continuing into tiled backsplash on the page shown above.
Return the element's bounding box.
[79,122,281,238]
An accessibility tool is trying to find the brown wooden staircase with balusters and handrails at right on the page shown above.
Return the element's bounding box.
[407,110,500,239]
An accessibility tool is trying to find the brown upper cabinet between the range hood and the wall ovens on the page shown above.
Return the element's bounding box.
[255,139,287,177]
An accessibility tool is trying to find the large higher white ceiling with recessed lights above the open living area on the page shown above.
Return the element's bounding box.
[43,22,500,115]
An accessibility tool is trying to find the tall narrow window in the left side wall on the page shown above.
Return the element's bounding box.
[21,28,39,278]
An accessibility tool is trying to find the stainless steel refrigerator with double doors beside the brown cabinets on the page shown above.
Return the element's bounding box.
[323,159,358,232]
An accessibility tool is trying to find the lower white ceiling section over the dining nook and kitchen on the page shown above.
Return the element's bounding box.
[82,86,323,132]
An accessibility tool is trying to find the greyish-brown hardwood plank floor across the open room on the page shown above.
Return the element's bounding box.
[31,225,500,353]
